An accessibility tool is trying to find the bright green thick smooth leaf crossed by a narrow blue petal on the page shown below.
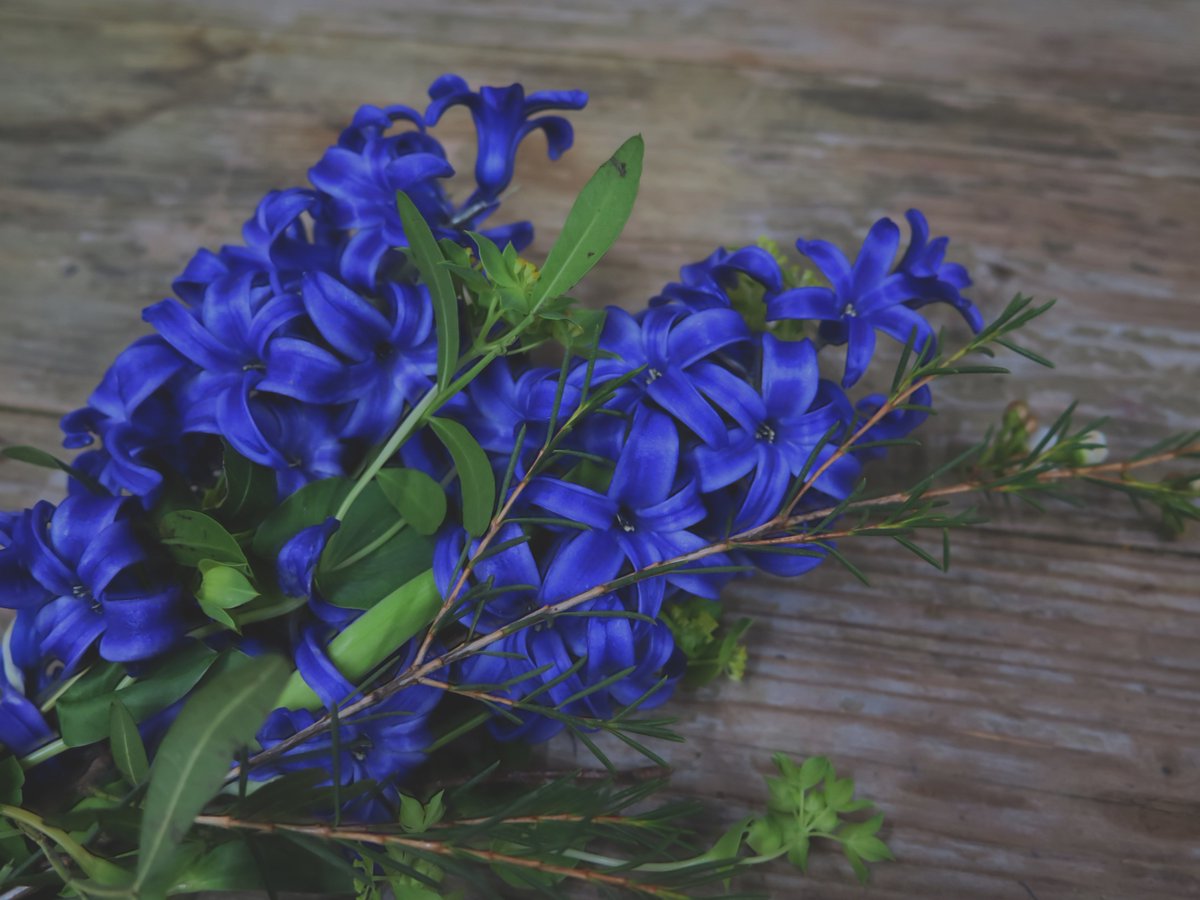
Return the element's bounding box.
[278,570,442,709]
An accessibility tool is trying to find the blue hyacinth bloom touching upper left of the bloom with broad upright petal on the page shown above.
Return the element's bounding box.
[594,306,754,446]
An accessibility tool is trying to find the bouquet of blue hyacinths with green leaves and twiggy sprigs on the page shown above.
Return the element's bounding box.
[0,76,1198,898]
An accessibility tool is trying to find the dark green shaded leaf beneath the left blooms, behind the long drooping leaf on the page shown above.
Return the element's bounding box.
[56,642,217,746]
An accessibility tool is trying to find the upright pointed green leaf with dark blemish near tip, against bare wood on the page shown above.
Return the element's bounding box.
[533,134,644,304]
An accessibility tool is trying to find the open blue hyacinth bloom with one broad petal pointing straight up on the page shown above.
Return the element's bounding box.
[692,334,862,530]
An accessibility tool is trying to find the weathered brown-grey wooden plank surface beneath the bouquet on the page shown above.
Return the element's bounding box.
[0,0,1200,900]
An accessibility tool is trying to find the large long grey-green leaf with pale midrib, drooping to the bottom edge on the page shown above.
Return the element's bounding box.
[133,655,289,894]
